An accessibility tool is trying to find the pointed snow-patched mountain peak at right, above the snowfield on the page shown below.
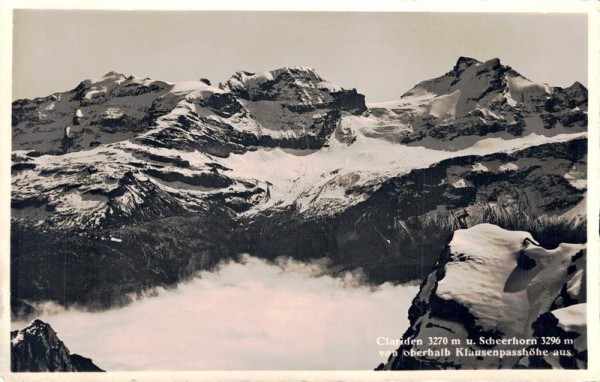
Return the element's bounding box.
[366,57,587,150]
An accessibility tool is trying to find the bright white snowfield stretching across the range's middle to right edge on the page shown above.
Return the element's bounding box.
[219,127,587,212]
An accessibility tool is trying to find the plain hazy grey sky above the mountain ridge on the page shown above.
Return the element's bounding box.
[13,10,587,102]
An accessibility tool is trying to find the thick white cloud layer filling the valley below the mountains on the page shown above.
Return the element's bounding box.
[13,256,418,371]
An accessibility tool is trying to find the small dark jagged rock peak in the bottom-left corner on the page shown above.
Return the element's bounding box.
[10,320,104,372]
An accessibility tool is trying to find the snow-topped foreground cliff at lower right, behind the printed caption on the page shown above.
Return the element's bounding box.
[379,224,587,369]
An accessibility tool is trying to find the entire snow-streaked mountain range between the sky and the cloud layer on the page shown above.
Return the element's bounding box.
[11,58,587,316]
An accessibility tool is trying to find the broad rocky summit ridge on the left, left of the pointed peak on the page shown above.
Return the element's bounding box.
[13,67,366,156]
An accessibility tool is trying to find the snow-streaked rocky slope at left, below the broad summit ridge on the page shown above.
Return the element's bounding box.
[12,142,264,231]
